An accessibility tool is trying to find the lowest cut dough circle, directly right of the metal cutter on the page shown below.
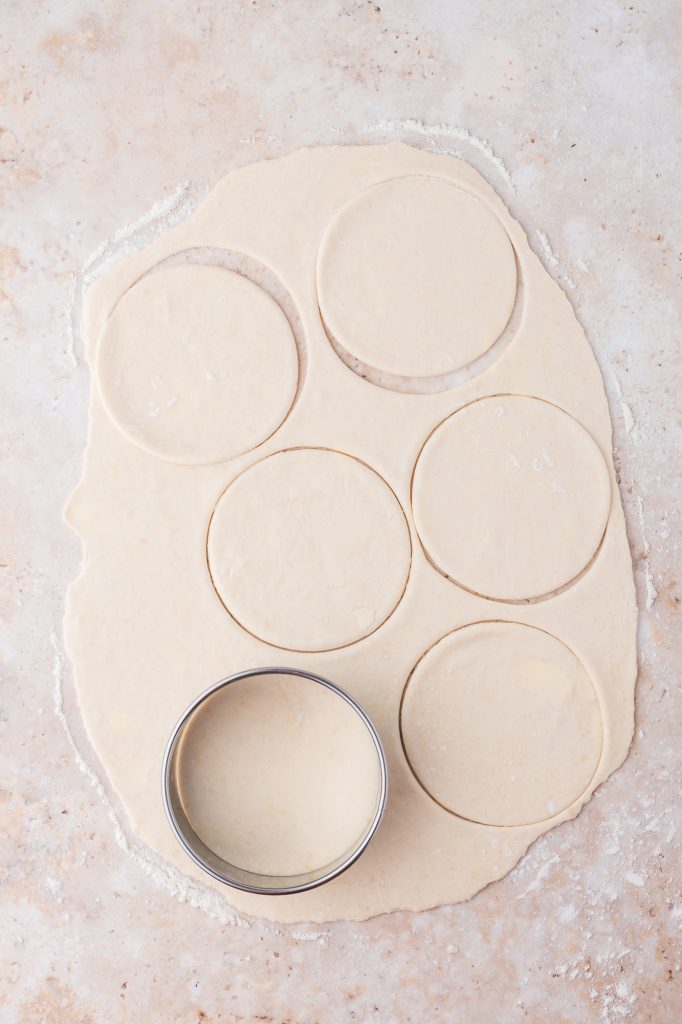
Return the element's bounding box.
[400,622,602,825]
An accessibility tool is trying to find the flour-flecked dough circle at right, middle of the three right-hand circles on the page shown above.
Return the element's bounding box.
[412,395,610,601]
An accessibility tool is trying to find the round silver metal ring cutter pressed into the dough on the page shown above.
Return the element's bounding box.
[162,667,388,896]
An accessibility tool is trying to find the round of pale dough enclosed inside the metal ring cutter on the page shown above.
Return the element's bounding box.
[178,675,381,876]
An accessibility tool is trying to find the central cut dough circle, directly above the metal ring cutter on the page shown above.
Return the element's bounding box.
[207,447,412,651]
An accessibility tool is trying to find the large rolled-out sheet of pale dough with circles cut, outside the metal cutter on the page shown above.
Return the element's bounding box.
[66,145,637,922]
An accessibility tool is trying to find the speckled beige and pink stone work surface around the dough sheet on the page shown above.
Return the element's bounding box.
[0,0,682,1024]
